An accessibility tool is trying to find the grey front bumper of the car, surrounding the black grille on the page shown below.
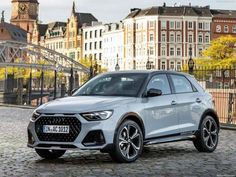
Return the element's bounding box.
[27,114,116,150]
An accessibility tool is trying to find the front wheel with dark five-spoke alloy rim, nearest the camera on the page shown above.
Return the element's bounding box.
[110,120,143,163]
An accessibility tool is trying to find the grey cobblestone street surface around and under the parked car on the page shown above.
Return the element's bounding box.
[0,107,236,177]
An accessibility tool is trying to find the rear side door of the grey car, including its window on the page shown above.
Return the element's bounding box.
[170,74,202,133]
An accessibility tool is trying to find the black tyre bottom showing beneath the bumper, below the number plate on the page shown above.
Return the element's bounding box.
[35,149,66,159]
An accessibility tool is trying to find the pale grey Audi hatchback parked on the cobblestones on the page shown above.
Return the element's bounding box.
[28,71,219,162]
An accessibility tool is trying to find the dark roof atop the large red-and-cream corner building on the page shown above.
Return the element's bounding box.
[126,6,212,19]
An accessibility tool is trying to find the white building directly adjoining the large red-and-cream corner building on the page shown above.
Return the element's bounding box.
[102,23,124,71]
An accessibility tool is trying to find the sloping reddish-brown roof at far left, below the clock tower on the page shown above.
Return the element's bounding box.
[0,22,27,42]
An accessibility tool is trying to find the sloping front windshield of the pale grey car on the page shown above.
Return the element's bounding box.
[73,73,148,97]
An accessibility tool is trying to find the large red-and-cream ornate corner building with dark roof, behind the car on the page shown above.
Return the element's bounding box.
[124,5,212,70]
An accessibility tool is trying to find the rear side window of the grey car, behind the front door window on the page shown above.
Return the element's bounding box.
[171,75,193,93]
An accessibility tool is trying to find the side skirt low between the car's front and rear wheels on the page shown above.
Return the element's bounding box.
[144,132,196,145]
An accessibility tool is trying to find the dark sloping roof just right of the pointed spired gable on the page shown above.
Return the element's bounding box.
[75,12,98,28]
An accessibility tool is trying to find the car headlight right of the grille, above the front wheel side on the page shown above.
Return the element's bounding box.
[80,110,113,121]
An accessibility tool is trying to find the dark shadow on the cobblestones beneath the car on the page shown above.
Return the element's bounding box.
[36,146,198,165]
